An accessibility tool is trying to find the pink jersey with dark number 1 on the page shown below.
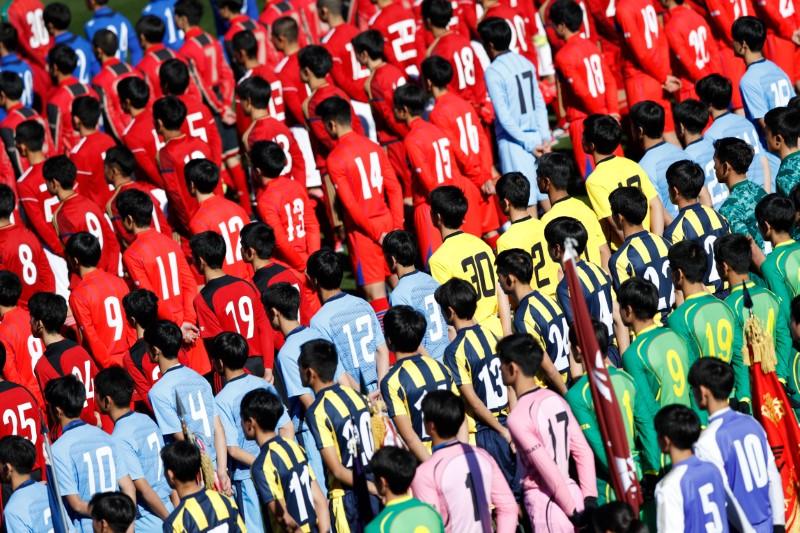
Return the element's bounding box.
[411,438,516,533]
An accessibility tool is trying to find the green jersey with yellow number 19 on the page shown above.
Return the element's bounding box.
[667,292,750,401]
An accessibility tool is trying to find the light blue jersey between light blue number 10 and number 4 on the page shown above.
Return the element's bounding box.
[111,411,172,533]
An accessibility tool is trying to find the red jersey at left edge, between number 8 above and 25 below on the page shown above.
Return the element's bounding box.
[0,306,44,405]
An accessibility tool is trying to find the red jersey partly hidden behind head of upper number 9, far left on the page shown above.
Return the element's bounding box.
[17,161,63,255]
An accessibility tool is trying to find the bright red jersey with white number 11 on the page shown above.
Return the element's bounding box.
[122,229,197,325]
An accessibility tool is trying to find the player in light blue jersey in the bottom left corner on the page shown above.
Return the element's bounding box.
[0,434,52,531]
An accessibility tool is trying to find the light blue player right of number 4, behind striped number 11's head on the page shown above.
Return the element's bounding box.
[208,331,294,532]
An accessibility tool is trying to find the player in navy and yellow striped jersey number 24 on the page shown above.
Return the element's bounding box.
[495,248,569,394]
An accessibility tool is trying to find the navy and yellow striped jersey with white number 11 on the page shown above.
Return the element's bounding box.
[251,436,317,533]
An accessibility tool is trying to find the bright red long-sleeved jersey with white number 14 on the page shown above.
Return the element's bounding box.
[328,132,403,242]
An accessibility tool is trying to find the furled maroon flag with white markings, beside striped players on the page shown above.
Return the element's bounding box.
[563,242,642,514]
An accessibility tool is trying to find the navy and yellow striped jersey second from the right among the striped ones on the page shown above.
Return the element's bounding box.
[608,231,675,322]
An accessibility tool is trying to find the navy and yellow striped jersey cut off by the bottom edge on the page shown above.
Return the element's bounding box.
[164,489,247,533]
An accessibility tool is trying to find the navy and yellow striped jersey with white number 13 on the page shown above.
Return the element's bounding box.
[444,324,508,429]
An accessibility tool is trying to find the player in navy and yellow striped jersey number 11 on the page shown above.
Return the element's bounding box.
[244,389,330,531]
